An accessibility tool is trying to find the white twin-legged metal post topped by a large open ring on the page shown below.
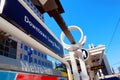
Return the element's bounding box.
[61,26,89,80]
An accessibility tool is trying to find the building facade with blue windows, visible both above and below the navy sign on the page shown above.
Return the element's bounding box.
[0,0,53,68]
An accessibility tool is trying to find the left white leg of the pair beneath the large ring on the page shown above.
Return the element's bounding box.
[69,52,80,80]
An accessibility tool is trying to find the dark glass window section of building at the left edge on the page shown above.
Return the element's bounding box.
[0,38,17,59]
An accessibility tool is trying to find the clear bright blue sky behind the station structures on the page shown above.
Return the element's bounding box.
[45,0,120,71]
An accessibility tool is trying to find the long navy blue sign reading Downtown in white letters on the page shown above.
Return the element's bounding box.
[2,0,63,57]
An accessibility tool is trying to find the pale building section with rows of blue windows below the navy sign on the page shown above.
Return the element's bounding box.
[17,42,53,68]
